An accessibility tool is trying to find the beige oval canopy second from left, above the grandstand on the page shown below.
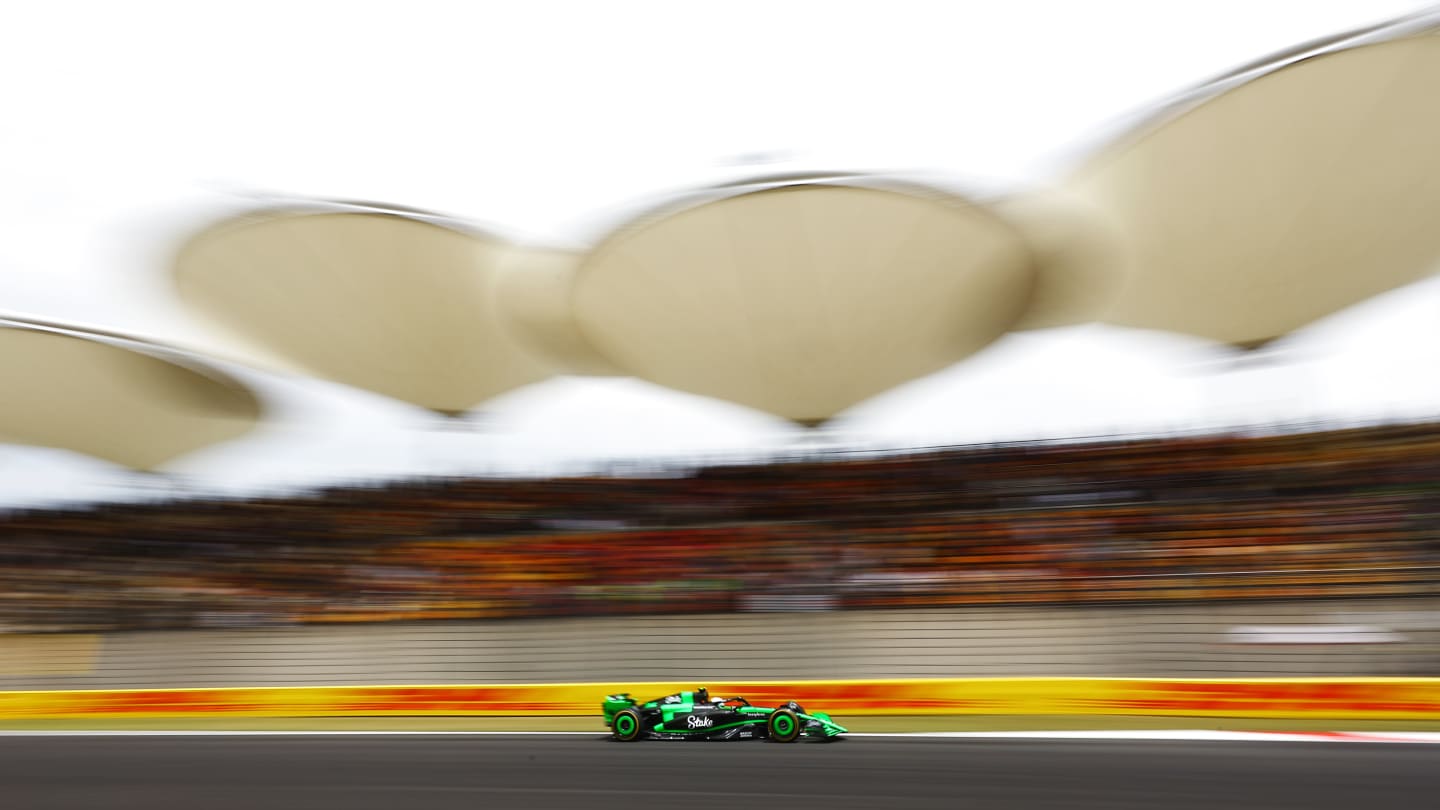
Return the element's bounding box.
[173,209,550,414]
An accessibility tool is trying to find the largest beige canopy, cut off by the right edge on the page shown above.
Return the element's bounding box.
[1066,14,1440,347]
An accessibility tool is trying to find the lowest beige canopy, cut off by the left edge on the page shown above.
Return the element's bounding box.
[0,319,261,470]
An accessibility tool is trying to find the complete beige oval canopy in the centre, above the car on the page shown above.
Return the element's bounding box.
[570,180,1035,424]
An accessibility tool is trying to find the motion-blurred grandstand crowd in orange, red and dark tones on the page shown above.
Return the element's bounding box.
[0,415,1440,631]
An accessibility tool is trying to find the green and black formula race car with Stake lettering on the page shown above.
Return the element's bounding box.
[600,687,845,742]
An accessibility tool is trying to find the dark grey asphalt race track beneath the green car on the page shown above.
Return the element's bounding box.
[0,735,1440,810]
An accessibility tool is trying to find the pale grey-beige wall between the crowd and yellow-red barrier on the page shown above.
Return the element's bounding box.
[0,600,1440,690]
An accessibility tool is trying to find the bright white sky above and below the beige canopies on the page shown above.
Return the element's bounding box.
[0,0,1440,504]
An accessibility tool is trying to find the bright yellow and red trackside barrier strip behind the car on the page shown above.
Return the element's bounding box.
[8,677,1440,719]
